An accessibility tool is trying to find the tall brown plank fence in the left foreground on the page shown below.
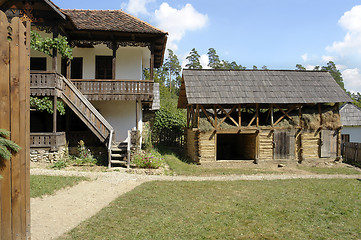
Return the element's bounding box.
[0,11,30,240]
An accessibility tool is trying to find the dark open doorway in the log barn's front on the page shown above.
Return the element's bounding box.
[217,133,256,160]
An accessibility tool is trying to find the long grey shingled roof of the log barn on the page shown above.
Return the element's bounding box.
[178,69,351,108]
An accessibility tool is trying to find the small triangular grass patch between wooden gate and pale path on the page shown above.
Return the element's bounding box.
[30,175,88,198]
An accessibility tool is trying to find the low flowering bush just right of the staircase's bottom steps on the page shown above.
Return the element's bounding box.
[132,151,164,169]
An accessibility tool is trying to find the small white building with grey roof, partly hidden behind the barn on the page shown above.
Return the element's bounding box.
[340,103,361,143]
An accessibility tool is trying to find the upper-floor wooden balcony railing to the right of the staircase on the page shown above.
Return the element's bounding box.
[71,79,154,102]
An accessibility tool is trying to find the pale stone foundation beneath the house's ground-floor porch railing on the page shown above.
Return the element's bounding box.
[30,147,68,163]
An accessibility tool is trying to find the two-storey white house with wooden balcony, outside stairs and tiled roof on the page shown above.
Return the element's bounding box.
[0,0,167,164]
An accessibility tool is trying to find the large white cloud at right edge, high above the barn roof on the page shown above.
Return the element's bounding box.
[326,5,361,57]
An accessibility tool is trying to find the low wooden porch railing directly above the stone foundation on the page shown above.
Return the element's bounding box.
[30,132,66,149]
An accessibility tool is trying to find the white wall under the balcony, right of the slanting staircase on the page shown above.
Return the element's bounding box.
[91,101,143,142]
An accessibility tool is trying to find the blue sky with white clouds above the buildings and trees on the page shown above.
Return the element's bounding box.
[59,0,361,92]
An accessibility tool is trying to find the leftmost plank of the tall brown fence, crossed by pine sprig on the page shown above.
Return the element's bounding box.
[0,11,12,239]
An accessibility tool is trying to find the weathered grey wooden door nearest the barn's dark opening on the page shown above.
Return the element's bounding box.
[273,130,295,159]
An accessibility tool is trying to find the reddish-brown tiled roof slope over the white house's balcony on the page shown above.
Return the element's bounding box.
[62,9,166,34]
